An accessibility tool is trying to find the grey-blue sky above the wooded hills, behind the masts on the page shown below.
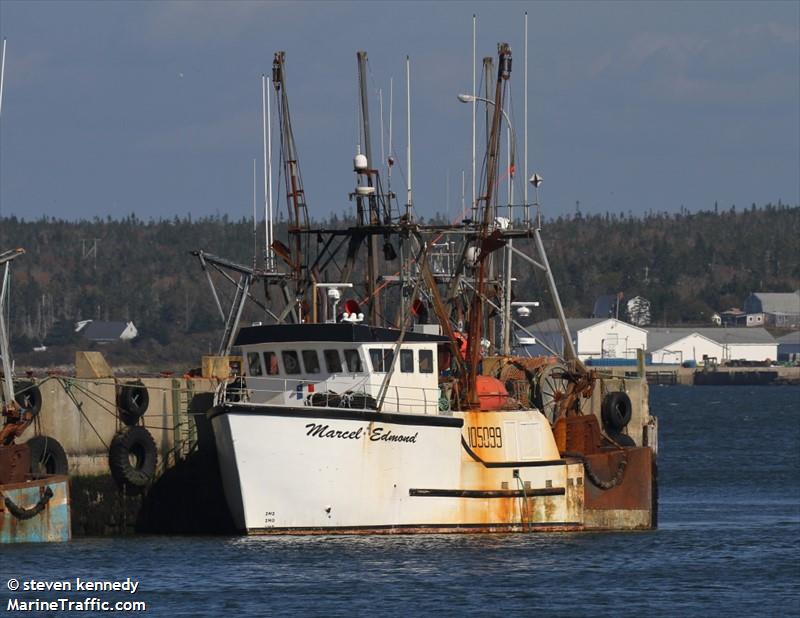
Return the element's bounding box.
[0,0,800,219]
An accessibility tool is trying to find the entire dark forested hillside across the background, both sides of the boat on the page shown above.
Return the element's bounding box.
[0,203,800,358]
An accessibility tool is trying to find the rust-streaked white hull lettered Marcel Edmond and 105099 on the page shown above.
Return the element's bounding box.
[212,405,583,534]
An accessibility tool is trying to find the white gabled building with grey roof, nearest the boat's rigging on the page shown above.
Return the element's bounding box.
[526,318,647,360]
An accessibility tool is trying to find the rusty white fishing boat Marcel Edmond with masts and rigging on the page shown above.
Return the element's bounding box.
[203,44,657,534]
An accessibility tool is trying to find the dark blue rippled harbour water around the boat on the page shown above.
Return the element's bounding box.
[0,387,800,616]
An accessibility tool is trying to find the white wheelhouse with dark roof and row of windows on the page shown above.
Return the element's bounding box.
[236,322,449,414]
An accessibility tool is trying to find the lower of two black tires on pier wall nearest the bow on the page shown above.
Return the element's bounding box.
[108,426,158,493]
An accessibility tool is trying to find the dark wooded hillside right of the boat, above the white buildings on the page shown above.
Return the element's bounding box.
[522,203,800,325]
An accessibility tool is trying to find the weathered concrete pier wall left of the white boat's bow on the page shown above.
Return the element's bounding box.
[13,376,233,537]
